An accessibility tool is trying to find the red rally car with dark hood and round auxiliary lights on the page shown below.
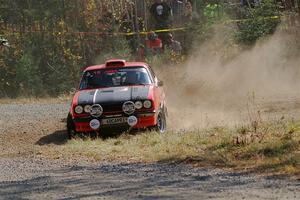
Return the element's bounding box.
[67,60,167,138]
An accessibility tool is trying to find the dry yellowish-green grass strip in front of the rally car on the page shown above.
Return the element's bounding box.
[39,120,300,175]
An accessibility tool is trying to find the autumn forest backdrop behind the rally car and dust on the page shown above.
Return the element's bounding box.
[0,0,300,98]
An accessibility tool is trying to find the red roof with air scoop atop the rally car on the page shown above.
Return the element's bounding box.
[83,59,149,72]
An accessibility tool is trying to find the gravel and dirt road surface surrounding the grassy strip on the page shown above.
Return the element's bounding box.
[0,102,300,199]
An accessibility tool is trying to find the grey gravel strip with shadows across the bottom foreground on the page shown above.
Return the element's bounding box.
[0,159,300,199]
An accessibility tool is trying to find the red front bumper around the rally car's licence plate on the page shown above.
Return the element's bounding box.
[73,111,157,132]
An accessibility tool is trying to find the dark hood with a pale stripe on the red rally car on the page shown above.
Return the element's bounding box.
[77,86,151,105]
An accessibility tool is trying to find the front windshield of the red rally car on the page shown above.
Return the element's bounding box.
[80,67,151,89]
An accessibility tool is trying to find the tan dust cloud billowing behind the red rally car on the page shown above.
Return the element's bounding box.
[156,26,300,129]
